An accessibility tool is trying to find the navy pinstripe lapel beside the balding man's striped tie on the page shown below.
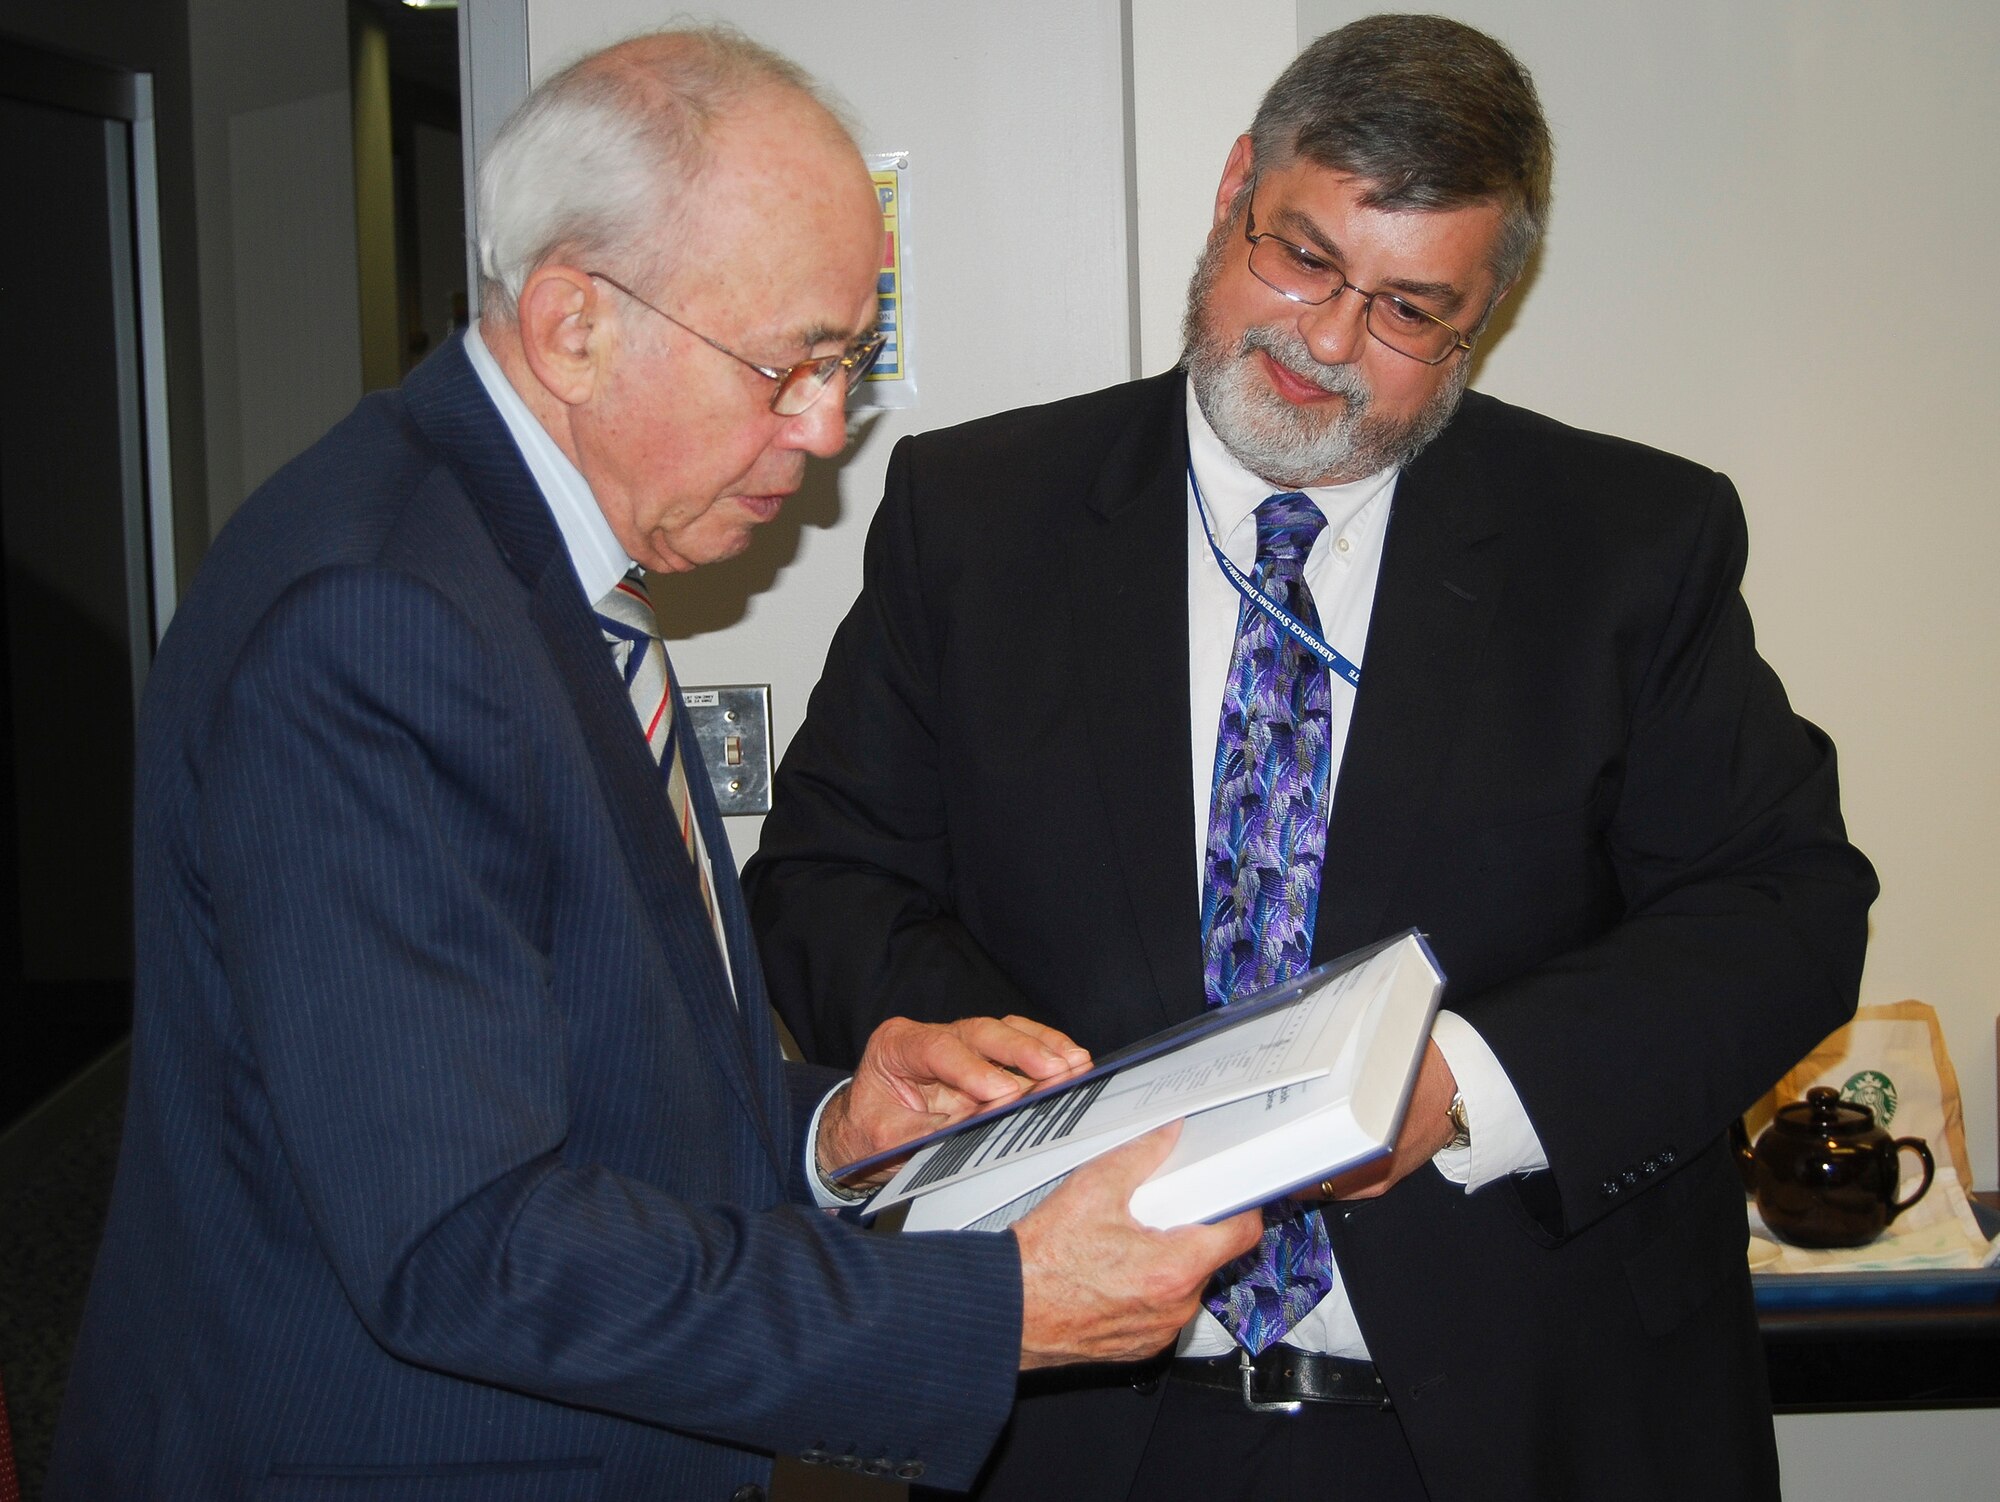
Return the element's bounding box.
[404,340,788,1180]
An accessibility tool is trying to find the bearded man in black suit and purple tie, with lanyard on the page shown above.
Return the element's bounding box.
[746,16,1876,1502]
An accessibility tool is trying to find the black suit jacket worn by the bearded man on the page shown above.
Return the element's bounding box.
[748,374,1874,1502]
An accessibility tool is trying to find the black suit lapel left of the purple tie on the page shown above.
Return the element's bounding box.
[1062,374,1202,1038]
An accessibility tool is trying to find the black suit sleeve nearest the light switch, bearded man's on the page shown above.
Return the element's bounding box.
[744,434,1028,1068]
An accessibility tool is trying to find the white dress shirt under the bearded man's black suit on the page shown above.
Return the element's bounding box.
[1178,386,1548,1358]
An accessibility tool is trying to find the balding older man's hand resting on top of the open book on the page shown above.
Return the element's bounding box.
[814,1016,1090,1182]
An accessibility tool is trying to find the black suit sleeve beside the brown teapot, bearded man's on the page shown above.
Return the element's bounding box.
[1458,476,1876,1234]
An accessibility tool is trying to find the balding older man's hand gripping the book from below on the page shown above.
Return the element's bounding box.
[1014,1122,1264,1372]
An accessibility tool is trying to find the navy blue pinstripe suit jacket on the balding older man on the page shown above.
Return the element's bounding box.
[48,342,1020,1502]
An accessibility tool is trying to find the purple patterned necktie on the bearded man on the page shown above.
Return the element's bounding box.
[1202,492,1334,1356]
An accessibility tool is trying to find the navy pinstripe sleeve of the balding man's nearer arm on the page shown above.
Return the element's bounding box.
[198,570,1020,1486]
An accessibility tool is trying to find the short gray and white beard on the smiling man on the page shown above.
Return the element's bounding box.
[1182,226,1472,490]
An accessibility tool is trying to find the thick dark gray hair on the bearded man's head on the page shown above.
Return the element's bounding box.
[1250,16,1556,286]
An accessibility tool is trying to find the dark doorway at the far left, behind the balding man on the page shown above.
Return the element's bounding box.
[0,40,172,1128]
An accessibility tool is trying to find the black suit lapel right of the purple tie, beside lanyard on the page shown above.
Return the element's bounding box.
[1312,396,1506,960]
